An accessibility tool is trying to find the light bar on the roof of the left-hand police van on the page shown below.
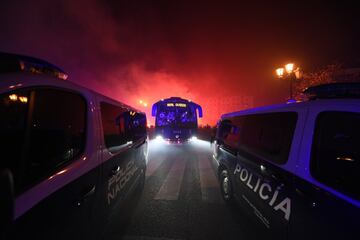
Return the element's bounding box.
[0,52,68,80]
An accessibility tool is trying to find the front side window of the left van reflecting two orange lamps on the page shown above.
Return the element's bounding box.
[0,89,86,193]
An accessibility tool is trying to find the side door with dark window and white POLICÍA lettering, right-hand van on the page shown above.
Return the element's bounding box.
[234,112,297,239]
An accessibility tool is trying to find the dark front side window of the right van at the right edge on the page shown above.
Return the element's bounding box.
[311,112,360,199]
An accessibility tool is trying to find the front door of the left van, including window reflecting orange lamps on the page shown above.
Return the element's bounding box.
[4,88,99,239]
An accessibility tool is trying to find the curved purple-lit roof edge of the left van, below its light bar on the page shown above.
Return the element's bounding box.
[0,72,145,114]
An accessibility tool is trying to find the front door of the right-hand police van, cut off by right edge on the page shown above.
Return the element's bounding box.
[290,104,360,239]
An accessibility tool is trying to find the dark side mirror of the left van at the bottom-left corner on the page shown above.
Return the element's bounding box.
[0,169,15,237]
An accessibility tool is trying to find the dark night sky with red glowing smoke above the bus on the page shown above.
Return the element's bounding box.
[0,0,360,124]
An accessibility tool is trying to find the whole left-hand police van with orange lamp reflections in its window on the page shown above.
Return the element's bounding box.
[0,53,148,239]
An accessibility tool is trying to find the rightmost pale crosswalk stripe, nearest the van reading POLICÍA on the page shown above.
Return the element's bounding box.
[198,154,222,203]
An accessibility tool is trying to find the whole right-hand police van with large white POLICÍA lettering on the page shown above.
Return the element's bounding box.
[214,83,360,239]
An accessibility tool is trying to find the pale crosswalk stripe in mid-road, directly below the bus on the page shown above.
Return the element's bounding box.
[154,158,186,200]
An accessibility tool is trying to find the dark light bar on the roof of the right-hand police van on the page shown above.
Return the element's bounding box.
[303,83,360,100]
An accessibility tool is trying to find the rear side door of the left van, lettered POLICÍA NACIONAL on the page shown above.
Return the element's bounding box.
[100,102,138,229]
